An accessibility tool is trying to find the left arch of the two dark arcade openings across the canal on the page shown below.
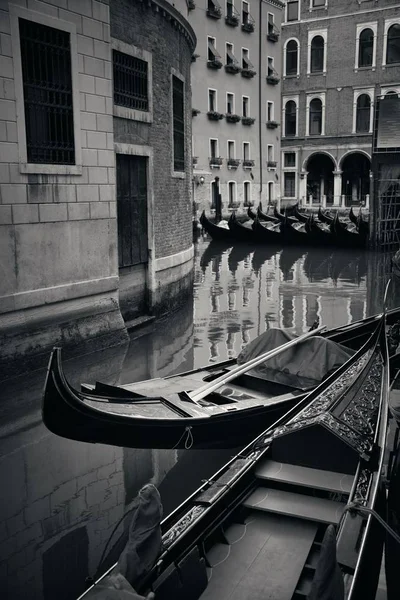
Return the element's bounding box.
[306,153,335,205]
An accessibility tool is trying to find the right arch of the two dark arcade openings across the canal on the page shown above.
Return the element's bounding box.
[341,152,371,206]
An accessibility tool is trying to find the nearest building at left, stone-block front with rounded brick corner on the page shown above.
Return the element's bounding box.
[0,0,196,368]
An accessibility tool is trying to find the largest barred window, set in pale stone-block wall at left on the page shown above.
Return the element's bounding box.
[19,19,75,165]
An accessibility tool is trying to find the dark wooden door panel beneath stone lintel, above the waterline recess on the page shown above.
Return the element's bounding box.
[117,154,148,268]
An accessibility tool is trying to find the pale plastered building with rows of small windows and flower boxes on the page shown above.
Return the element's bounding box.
[188,0,284,216]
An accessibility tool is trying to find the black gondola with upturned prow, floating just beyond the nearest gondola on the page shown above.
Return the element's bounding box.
[42,310,400,448]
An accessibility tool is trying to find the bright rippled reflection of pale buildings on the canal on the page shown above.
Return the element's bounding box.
[194,238,383,366]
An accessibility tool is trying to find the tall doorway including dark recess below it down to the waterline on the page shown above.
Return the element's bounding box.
[117,154,148,321]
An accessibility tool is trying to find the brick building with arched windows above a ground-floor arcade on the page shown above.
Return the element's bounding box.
[282,0,400,207]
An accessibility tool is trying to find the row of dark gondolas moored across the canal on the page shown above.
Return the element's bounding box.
[200,204,368,248]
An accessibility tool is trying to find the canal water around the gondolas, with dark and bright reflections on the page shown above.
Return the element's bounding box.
[0,237,400,600]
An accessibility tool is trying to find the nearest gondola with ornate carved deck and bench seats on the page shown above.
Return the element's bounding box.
[77,316,389,600]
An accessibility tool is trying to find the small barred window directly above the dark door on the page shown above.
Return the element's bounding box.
[113,50,149,111]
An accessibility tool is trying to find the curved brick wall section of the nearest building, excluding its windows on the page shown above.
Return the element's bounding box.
[110,0,193,258]
